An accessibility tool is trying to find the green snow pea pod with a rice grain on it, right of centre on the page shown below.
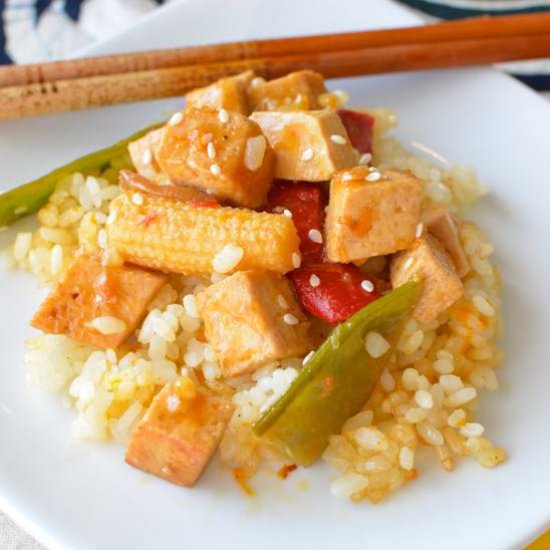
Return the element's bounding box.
[253,282,420,466]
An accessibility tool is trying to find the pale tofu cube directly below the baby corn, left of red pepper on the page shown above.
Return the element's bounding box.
[197,271,313,377]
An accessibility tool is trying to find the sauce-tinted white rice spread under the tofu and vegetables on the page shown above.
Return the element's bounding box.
[5,109,506,502]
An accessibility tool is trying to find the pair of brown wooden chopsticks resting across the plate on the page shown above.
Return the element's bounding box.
[0,13,550,120]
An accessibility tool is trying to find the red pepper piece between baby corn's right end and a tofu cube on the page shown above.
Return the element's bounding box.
[267,181,327,265]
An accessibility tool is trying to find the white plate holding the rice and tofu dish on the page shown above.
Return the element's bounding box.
[0,0,550,550]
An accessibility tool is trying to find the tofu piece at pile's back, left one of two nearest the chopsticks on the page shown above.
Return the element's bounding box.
[185,71,254,115]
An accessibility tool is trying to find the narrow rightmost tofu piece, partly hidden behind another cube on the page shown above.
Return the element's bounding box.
[422,206,470,279]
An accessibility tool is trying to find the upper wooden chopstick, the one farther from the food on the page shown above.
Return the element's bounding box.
[0,13,550,87]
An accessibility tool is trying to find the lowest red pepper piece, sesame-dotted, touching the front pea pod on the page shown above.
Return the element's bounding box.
[288,263,382,325]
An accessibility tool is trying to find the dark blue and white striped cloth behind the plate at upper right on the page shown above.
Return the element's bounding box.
[399,0,550,90]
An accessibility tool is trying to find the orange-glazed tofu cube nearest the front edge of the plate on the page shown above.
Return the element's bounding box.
[126,378,233,487]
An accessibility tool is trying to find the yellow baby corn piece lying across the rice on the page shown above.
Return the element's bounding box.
[108,193,299,275]
